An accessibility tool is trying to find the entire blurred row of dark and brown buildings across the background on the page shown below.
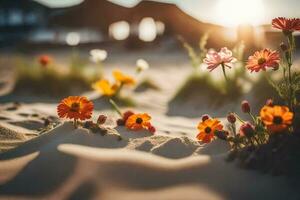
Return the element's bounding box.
[0,0,292,49]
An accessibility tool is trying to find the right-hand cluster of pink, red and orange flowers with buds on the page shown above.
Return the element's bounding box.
[197,17,300,148]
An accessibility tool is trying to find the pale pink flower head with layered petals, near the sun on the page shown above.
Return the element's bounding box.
[203,47,236,71]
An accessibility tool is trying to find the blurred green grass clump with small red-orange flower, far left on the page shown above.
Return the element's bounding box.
[13,54,93,98]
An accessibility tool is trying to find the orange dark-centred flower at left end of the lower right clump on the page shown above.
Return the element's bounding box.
[197,118,223,143]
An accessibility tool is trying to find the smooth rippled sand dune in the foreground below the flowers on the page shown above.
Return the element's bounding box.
[0,123,299,200]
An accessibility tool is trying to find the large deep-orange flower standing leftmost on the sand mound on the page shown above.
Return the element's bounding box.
[57,96,94,120]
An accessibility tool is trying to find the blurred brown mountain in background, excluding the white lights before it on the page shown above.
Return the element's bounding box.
[50,0,230,46]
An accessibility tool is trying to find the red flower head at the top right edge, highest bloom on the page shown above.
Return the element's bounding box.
[272,17,300,33]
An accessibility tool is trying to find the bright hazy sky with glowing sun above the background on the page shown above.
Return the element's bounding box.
[37,0,300,26]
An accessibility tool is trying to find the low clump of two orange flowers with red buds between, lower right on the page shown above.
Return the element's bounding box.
[197,100,294,148]
